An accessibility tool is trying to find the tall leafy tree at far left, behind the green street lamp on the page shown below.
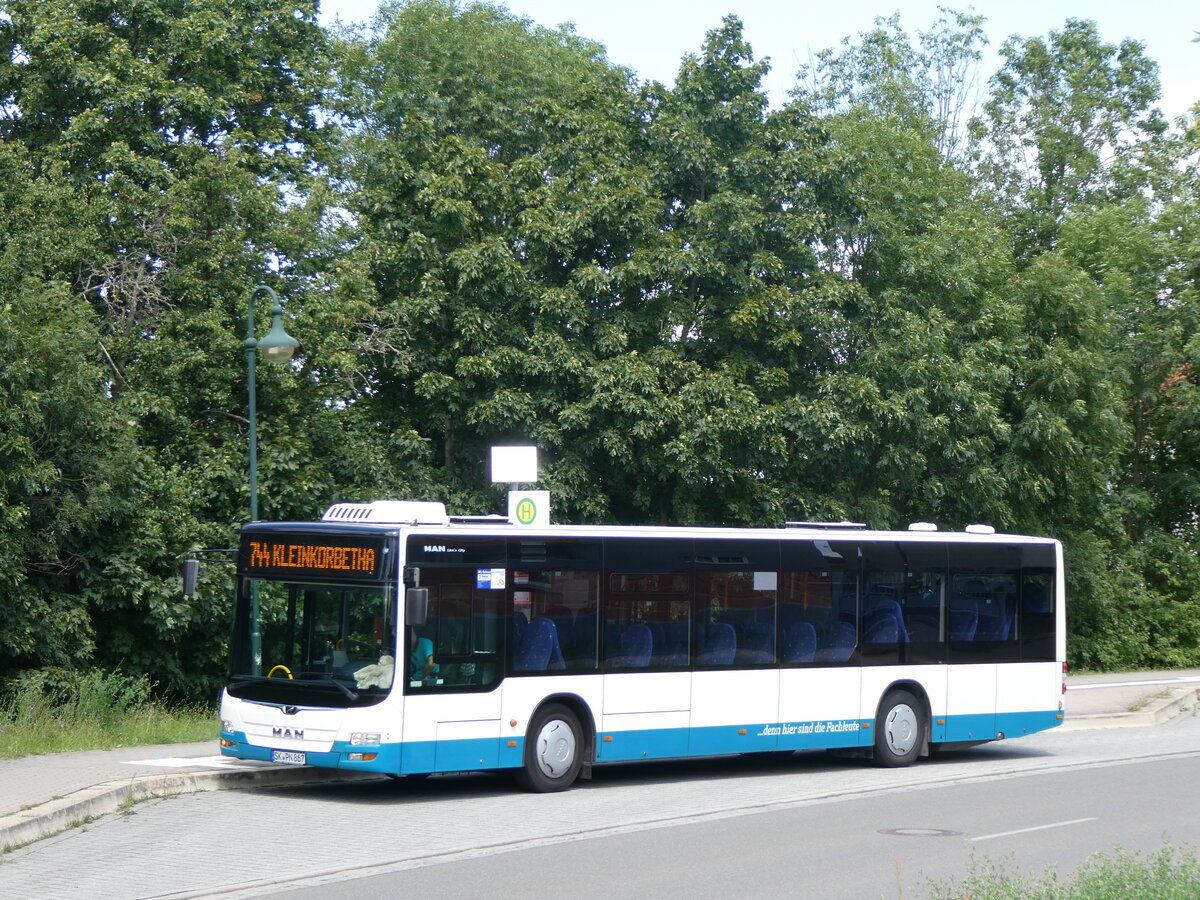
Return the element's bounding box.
[0,0,325,696]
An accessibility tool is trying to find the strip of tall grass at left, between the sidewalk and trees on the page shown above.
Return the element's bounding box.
[0,671,217,760]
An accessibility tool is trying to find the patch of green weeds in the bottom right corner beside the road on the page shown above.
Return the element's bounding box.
[929,845,1200,900]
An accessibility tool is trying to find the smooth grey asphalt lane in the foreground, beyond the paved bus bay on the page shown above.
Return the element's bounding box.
[275,755,1200,900]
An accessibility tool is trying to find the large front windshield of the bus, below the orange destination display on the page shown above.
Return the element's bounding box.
[228,577,396,707]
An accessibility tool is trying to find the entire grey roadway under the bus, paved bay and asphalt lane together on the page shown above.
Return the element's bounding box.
[0,714,1200,900]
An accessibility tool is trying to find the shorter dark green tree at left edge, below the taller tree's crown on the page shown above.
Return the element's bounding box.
[0,280,137,674]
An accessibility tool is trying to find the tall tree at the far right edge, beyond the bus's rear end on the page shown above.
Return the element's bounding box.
[974,19,1200,666]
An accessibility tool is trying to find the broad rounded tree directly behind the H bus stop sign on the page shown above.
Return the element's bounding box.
[340,0,686,516]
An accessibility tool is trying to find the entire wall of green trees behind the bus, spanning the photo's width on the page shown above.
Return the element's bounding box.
[0,0,1200,700]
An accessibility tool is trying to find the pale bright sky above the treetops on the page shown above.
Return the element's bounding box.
[320,0,1200,119]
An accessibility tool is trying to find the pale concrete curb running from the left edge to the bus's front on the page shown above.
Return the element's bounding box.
[0,767,378,854]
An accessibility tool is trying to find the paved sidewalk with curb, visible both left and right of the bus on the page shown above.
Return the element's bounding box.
[0,670,1200,853]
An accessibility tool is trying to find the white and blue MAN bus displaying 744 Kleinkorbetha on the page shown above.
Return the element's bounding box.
[221,500,1066,791]
